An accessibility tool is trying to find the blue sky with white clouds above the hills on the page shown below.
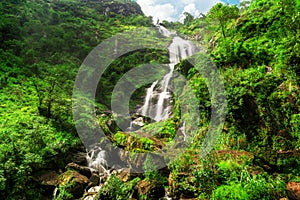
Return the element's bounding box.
[137,0,239,22]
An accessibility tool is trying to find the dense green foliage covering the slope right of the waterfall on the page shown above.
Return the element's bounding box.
[169,0,300,199]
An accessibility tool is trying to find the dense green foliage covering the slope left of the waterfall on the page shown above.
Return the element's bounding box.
[0,0,154,199]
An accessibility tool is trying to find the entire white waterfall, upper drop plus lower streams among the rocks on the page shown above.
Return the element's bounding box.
[68,26,195,200]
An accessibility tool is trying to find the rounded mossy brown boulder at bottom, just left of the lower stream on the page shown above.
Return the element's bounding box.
[57,170,89,198]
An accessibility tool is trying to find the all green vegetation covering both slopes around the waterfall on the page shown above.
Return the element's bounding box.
[0,0,300,200]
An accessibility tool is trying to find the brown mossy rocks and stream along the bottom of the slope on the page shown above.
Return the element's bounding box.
[31,145,300,200]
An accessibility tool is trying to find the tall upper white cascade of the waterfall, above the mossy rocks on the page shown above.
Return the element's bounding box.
[139,26,195,121]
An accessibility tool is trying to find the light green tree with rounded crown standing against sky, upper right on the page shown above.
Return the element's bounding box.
[207,3,239,39]
